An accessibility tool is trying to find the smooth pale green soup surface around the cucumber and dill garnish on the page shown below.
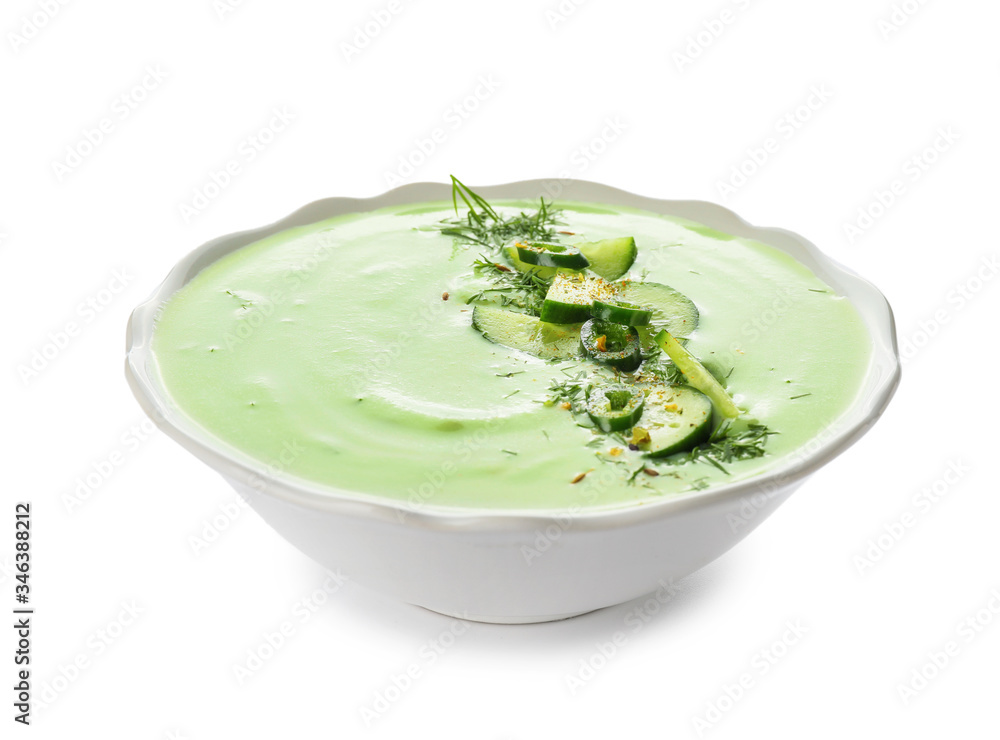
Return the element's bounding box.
[152,198,870,509]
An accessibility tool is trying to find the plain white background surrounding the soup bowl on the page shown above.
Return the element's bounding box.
[0,0,1000,740]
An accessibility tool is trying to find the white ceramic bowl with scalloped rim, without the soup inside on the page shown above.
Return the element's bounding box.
[126,180,900,623]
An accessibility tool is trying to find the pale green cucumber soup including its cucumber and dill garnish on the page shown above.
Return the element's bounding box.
[152,180,870,510]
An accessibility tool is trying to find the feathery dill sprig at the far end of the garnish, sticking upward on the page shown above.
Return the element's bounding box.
[435,175,561,250]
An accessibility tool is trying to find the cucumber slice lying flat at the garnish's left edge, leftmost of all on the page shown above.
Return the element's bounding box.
[472,306,580,360]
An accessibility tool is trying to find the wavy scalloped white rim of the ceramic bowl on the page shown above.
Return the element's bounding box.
[125,178,901,531]
